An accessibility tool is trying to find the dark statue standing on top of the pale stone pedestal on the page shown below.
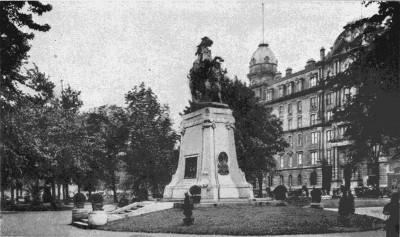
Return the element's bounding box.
[188,37,226,103]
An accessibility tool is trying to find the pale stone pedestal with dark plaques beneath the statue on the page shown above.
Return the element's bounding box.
[164,107,254,202]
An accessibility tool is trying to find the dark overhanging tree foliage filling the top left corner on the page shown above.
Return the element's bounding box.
[0,1,52,109]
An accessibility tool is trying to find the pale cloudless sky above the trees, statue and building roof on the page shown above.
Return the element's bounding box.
[29,0,377,128]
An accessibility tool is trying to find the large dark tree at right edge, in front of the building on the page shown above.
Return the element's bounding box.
[327,1,400,187]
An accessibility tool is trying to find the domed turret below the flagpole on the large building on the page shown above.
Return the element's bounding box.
[249,44,278,75]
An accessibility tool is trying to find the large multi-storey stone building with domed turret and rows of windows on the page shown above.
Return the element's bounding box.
[248,31,400,193]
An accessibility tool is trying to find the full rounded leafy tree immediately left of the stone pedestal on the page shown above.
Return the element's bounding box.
[125,83,178,196]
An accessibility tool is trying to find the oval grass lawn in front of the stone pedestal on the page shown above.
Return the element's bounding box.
[97,206,383,235]
